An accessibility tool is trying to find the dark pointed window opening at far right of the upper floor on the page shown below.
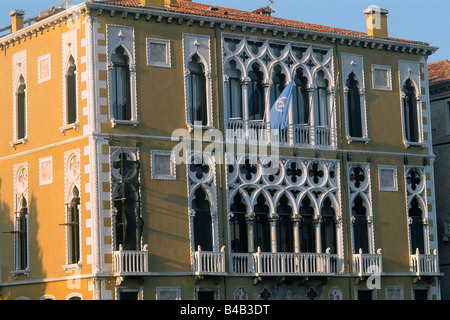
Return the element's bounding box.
[402,79,420,142]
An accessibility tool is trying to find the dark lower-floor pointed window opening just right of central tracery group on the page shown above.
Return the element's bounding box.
[351,195,370,253]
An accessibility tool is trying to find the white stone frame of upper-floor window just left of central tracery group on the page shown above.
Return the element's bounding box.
[183,33,214,131]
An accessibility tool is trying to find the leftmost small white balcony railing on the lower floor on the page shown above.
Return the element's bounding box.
[113,245,148,276]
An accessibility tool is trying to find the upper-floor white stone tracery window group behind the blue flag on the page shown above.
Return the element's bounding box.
[222,35,336,147]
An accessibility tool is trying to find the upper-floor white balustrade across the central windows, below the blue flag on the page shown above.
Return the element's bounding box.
[226,119,335,148]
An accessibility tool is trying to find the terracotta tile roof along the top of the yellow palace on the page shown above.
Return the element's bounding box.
[96,0,429,45]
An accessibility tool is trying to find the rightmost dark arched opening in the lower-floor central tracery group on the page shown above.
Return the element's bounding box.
[320,197,337,253]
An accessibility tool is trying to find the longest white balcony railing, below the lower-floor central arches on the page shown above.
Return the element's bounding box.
[230,248,338,276]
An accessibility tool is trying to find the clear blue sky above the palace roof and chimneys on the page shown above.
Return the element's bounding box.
[0,0,450,62]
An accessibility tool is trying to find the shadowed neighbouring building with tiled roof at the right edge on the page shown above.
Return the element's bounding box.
[428,60,450,300]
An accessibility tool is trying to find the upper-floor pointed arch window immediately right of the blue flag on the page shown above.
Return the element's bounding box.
[292,68,309,124]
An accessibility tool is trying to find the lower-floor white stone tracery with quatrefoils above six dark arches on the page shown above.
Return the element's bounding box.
[227,154,342,254]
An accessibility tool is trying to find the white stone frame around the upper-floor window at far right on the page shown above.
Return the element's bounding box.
[398,60,425,148]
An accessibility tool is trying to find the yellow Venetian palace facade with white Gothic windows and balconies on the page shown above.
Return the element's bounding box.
[0,0,440,300]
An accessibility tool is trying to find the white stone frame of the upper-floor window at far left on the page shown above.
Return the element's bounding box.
[9,50,28,149]
